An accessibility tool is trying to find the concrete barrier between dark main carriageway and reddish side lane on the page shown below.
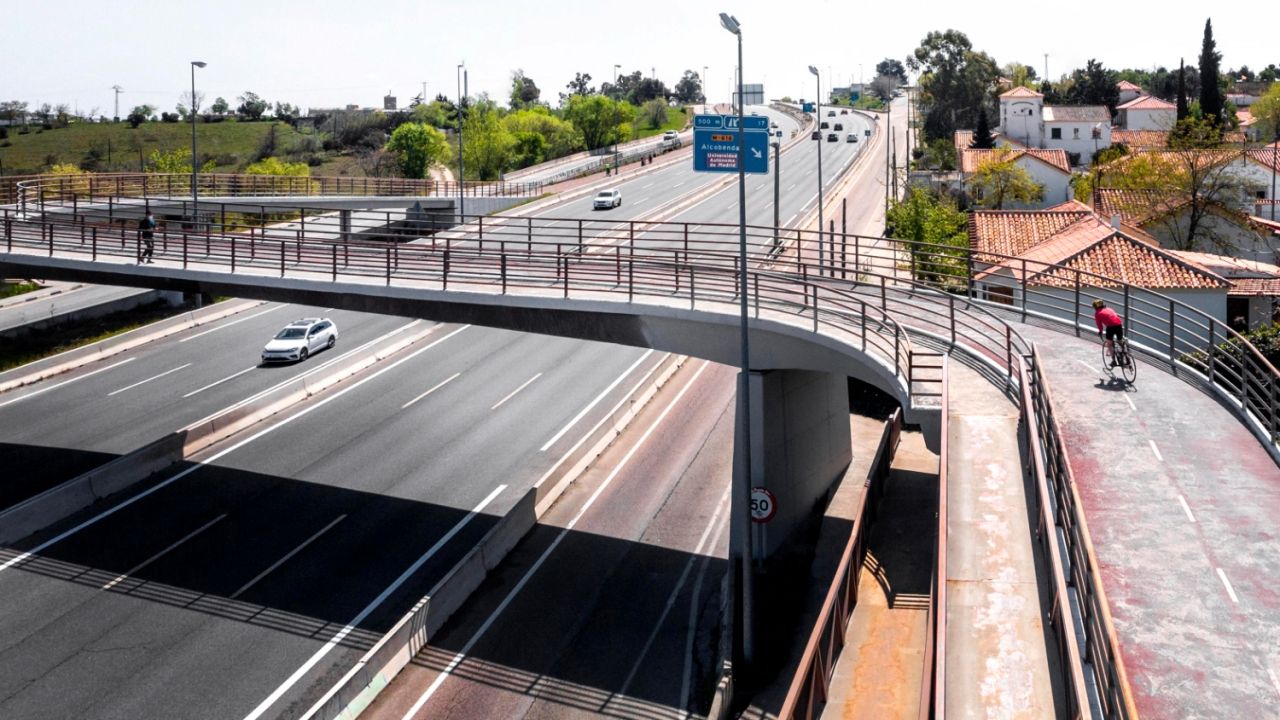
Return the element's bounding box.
[302,355,687,720]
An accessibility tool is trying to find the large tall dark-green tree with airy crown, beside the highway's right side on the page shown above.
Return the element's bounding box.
[906,29,1000,140]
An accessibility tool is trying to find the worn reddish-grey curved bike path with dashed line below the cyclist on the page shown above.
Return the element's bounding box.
[1018,324,1280,719]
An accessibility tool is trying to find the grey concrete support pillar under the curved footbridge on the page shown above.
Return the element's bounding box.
[750,370,852,559]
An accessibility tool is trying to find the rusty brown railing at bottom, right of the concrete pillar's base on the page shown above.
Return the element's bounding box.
[778,410,902,720]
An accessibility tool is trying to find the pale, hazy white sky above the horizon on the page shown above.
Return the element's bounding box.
[0,0,1280,117]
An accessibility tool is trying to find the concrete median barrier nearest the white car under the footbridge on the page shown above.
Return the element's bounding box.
[0,325,439,543]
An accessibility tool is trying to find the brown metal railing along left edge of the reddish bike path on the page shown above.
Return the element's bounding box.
[1021,350,1138,720]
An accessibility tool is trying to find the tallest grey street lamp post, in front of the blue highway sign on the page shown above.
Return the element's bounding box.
[721,7,754,666]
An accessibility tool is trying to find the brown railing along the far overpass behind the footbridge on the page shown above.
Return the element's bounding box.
[0,173,543,205]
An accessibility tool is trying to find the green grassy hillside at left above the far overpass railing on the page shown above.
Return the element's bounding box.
[0,120,314,176]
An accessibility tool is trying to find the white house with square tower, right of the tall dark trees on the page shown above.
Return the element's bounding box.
[1000,87,1111,165]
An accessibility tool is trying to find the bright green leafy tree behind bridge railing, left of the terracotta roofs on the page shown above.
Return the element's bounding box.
[884,186,969,283]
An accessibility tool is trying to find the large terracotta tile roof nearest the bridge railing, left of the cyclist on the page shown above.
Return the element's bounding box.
[977,215,1230,290]
